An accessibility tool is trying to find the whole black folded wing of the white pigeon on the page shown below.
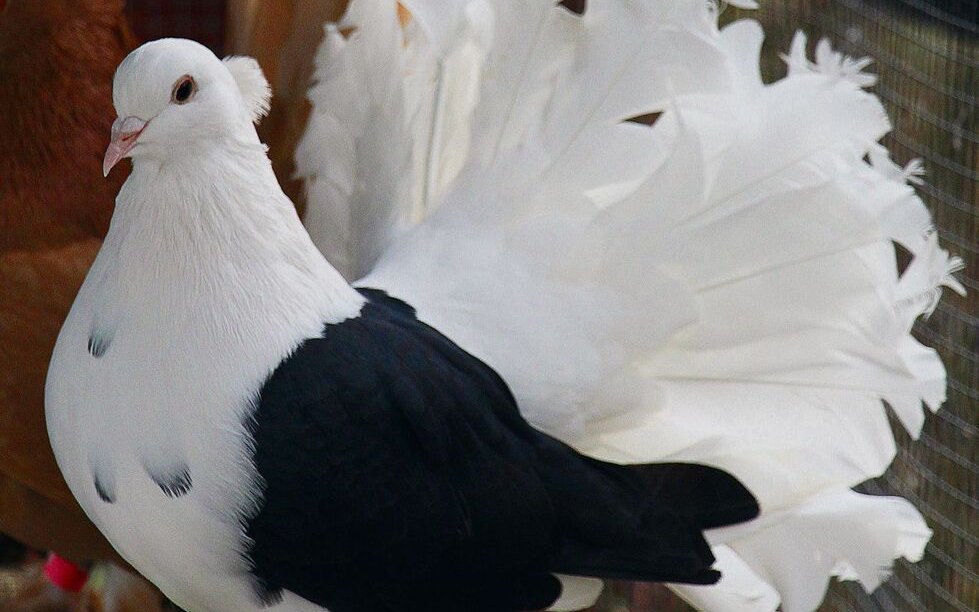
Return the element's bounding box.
[246,290,757,612]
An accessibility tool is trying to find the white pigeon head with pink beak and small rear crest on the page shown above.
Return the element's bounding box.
[102,38,271,175]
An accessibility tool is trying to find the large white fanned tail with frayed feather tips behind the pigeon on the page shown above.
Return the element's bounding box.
[298,0,962,611]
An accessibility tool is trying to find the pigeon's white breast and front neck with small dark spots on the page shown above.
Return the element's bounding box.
[47,154,362,610]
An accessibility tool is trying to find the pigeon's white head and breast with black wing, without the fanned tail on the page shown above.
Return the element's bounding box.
[47,40,757,612]
